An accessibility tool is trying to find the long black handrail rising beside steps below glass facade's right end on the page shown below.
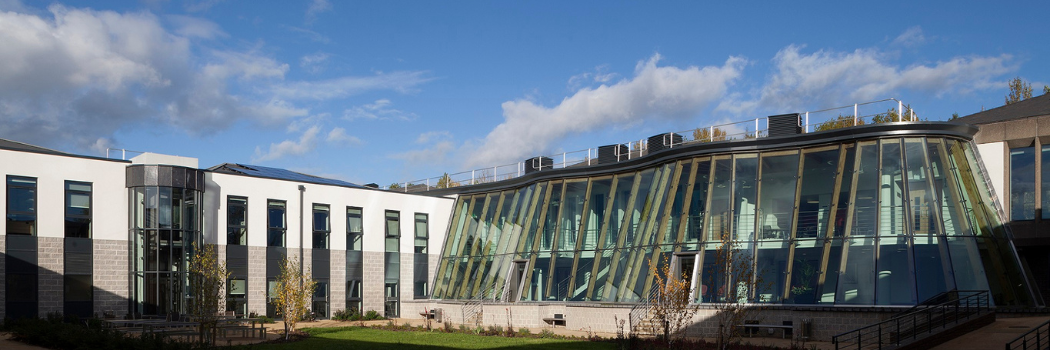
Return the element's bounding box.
[832,290,991,349]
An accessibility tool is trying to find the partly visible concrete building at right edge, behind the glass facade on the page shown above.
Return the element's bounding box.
[957,95,1050,297]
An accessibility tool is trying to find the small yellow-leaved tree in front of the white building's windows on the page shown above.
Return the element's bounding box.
[273,255,317,339]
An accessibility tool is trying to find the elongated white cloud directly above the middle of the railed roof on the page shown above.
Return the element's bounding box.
[467,54,746,166]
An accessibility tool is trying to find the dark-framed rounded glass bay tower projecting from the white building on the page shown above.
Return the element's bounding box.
[129,186,203,315]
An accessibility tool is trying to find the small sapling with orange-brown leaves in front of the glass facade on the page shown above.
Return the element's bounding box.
[649,255,700,348]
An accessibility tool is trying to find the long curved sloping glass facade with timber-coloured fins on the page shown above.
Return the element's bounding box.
[433,136,1033,306]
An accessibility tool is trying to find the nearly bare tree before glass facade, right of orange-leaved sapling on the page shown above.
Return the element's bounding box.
[705,231,772,349]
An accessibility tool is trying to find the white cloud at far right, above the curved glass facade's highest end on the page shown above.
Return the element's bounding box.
[718,45,1016,114]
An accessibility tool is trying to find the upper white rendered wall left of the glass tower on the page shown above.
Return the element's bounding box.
[0,149,129,241]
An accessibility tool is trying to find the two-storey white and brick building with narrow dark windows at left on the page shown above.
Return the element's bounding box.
[0,140,453,317]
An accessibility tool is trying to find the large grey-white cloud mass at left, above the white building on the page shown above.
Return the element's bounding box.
[0,2,428,150]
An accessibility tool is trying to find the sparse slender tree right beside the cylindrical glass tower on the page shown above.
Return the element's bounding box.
[189,242,230,342]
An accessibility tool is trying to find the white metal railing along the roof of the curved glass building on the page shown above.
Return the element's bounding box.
[387,98,918,192]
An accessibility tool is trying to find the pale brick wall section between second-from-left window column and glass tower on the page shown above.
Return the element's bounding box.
[91,240,130,316]
